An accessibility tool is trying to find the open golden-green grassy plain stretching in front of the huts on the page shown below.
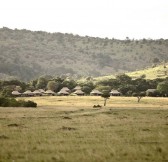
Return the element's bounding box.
[0,96,168,162]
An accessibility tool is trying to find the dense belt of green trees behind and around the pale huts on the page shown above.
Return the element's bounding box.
[0,74,168,97]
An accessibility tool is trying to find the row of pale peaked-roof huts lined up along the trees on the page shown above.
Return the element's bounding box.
[12,86,121,97]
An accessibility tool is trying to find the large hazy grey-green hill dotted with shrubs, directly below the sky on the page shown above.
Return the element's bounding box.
[0,28,168,81]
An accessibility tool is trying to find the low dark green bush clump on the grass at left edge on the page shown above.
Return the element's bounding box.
[0,97,37,107]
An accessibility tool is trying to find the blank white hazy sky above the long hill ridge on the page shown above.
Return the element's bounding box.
[0,0,168,39]
